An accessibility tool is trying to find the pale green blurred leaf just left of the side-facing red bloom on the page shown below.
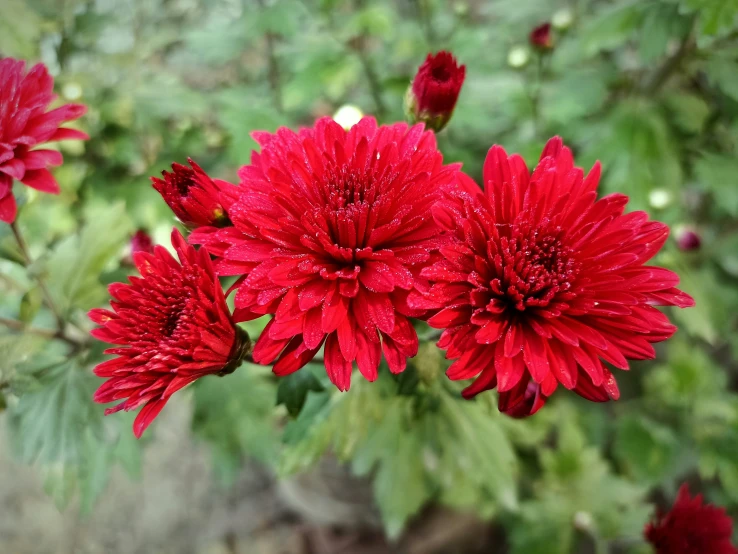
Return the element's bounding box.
[46,203,131,314]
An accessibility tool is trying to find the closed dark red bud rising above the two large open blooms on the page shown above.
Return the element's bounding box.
[405,51,466,131]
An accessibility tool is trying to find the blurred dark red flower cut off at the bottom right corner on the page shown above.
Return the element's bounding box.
[644,484,738,554]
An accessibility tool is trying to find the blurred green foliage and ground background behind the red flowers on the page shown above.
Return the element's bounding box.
[0,0,738,554]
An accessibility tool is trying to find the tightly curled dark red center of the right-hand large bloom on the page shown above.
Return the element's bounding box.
[488,224,580,311]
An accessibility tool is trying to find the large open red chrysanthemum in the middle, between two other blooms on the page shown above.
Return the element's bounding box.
[191,117,459,390]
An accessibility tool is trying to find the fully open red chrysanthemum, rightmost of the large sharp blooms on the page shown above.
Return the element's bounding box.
[409,137,694,416]
